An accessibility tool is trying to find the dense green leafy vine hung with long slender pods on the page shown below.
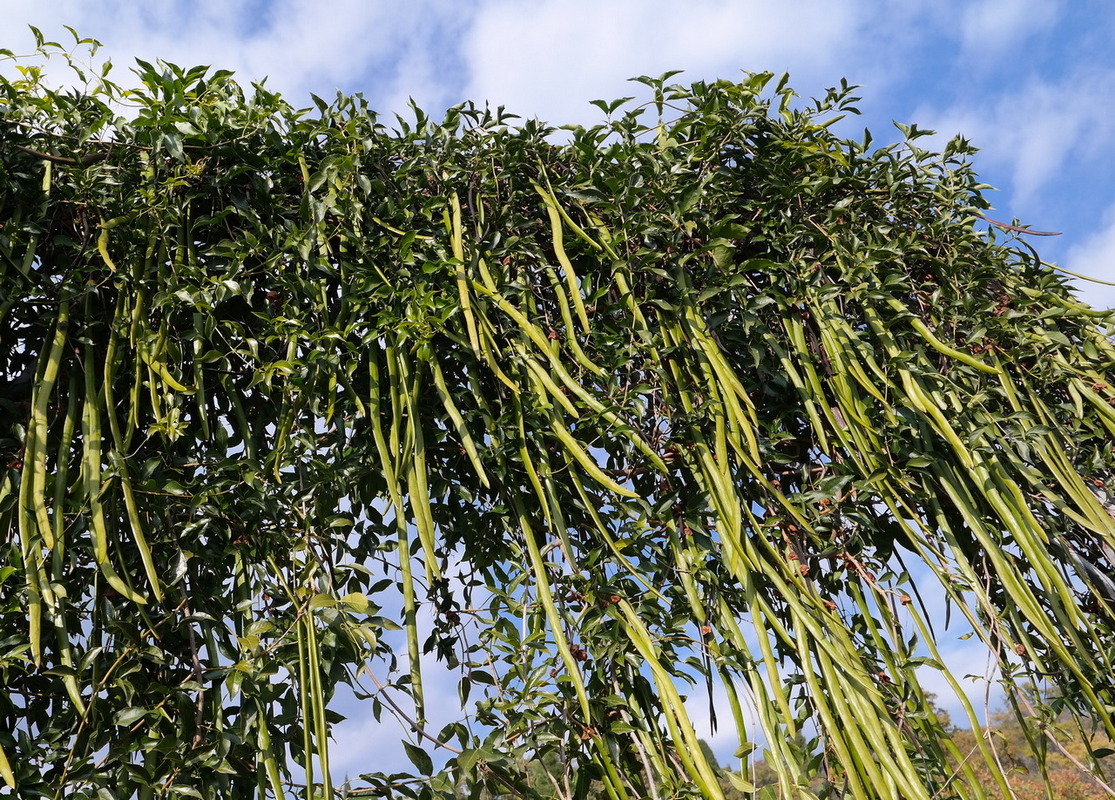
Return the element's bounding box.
[0,31,1115,800]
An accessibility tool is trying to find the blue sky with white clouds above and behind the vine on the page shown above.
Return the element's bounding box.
[8,0,1115,774]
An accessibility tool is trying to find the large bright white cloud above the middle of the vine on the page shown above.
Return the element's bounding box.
[464,0,859,124]
